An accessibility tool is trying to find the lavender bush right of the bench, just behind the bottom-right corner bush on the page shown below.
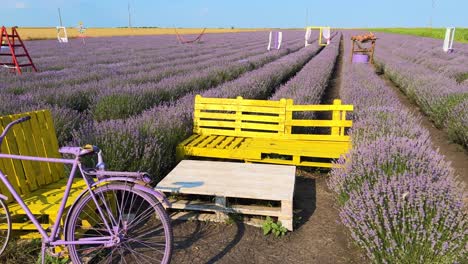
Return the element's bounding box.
[329,135,453,204]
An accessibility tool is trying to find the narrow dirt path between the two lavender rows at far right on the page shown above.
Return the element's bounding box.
[379,74,468,186]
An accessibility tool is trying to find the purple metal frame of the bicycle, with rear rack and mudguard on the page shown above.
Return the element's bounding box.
[0,153,169,246]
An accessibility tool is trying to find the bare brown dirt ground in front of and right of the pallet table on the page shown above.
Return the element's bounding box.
[173,174,361,263]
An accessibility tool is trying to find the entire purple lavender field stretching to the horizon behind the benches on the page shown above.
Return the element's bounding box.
[0,30,468,263]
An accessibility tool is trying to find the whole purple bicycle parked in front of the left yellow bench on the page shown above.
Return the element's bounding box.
[0,117,173,263]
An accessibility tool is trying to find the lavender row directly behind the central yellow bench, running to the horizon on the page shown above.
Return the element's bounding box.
[75,37,328,179]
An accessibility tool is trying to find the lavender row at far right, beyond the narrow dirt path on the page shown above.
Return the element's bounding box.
[376,35,468,149]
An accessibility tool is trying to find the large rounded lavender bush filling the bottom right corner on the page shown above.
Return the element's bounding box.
[340,171,468,263]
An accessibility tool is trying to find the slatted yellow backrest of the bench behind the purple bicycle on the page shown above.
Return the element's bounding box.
[0,110,64,198]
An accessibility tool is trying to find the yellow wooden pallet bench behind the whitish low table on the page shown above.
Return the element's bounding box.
[177,95,353,168]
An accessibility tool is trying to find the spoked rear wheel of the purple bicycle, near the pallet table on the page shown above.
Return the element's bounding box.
[66,183,172,263]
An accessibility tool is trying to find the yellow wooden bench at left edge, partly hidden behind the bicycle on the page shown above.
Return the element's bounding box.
[0,110,85,236]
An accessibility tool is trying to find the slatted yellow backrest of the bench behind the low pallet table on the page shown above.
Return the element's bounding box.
[194,95,353,141]
